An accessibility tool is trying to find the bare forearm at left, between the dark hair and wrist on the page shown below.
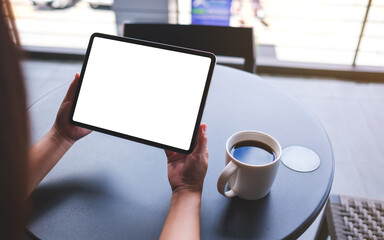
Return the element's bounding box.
[27,127,73,195]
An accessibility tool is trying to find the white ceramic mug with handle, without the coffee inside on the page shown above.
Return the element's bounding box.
[217,131,282,200]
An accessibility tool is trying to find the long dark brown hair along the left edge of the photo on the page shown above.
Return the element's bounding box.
[0,0,29,239]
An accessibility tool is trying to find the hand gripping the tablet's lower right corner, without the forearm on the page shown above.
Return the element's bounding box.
[165,124,208,193]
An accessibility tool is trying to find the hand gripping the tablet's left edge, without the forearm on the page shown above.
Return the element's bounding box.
[51,73,91,145]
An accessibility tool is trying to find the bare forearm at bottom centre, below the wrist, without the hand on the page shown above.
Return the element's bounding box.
[160,192,201,240]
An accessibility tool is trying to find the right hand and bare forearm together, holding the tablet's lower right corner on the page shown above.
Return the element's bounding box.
[160,124,208,240]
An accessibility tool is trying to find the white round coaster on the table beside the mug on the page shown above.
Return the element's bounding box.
[281,146,320,172]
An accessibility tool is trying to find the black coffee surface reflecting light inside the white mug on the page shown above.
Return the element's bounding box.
[230,140,276,165]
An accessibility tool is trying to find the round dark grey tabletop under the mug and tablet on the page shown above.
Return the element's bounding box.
[29,65,334,239]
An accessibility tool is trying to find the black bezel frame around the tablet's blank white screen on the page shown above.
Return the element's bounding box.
[69,33,216,154]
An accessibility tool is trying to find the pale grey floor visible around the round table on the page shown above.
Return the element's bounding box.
[23,60,384,239]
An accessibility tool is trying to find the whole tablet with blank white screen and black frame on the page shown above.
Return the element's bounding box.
[70,33,216,154]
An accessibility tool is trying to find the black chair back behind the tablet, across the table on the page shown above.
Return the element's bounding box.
[123,23,256,73]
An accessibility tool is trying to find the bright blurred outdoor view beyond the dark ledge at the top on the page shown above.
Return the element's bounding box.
[11,0,384,67]
